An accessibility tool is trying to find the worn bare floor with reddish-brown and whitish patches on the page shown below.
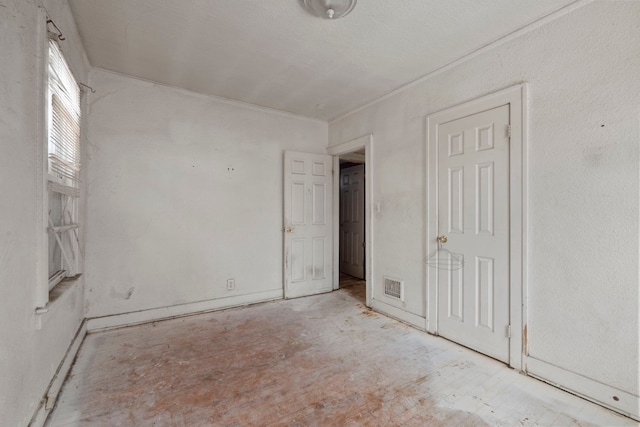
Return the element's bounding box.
[48,282,637,426]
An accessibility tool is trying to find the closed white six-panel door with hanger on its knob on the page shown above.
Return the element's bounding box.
[438,105,509,363]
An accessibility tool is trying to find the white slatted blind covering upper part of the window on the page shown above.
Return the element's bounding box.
[49,40,80,187]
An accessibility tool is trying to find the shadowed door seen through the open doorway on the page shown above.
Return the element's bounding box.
[340,165,365,279]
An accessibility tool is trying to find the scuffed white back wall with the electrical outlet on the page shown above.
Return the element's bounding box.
[86,70,328,317]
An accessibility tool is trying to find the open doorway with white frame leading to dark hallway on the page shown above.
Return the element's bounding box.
[327,135,373,307]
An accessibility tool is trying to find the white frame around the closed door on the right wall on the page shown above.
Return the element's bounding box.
[425,83,527,371]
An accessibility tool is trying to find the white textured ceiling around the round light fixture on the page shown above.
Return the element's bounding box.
[69,0,573,120]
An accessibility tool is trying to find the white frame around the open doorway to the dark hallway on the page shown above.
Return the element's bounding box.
[327,133,373,307]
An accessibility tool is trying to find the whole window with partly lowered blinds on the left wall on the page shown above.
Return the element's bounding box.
[47,40,80,290]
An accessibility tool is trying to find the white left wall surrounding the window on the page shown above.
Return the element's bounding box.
[0,0,88,426]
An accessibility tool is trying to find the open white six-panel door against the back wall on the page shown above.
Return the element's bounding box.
[284,151,333,298]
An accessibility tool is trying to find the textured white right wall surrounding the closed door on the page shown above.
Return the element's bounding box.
[329,2,640,414]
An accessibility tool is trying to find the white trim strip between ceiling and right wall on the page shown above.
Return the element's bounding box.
[329,0,595,123]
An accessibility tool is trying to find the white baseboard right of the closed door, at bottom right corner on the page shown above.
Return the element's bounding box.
[525,356,640,421]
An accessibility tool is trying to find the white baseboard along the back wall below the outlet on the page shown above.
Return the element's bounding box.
[87,289,282,332]
